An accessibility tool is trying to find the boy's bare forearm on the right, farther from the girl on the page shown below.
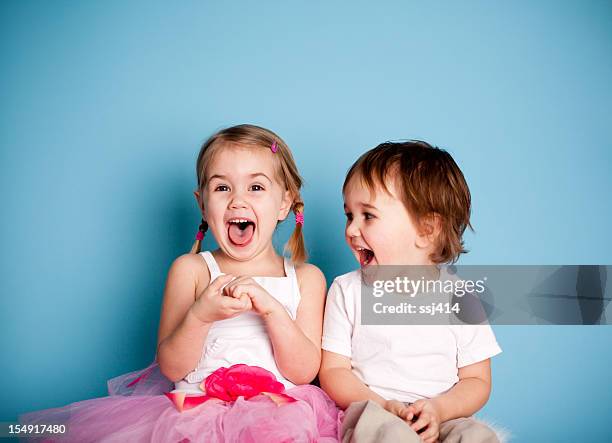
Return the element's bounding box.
[431,358,491,422]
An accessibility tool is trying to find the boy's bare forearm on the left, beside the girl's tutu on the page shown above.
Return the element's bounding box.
[319,350,386,409]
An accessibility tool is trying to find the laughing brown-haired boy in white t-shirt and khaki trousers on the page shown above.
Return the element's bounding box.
[319,141,501,443]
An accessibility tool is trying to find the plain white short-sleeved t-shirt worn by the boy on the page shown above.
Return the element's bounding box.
[322,270,501,402]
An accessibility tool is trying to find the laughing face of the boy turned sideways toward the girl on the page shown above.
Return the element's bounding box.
[344,176,433,267]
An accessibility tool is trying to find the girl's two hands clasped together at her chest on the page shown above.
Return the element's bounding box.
[191,274,282,323]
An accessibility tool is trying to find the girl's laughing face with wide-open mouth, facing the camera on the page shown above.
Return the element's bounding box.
[196,144,292,261]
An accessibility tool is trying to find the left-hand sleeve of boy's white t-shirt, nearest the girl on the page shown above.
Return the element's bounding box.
[321,280,353,357]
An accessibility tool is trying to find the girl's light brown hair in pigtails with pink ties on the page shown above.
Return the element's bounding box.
[191,125,307,263]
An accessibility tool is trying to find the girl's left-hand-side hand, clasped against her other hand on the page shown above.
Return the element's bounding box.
[190,275,253,324]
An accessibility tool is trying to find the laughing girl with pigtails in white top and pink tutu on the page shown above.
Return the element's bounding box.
[20,125,338,442]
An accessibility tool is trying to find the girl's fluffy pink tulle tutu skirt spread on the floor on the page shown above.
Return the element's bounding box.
[19,362,340,443]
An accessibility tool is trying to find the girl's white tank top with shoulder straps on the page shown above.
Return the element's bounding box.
[175,251,300,393]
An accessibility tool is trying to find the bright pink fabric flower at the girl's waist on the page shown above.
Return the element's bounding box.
[200,364,285,401]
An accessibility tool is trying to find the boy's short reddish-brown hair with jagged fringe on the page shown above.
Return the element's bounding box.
[342,140,473,263]
